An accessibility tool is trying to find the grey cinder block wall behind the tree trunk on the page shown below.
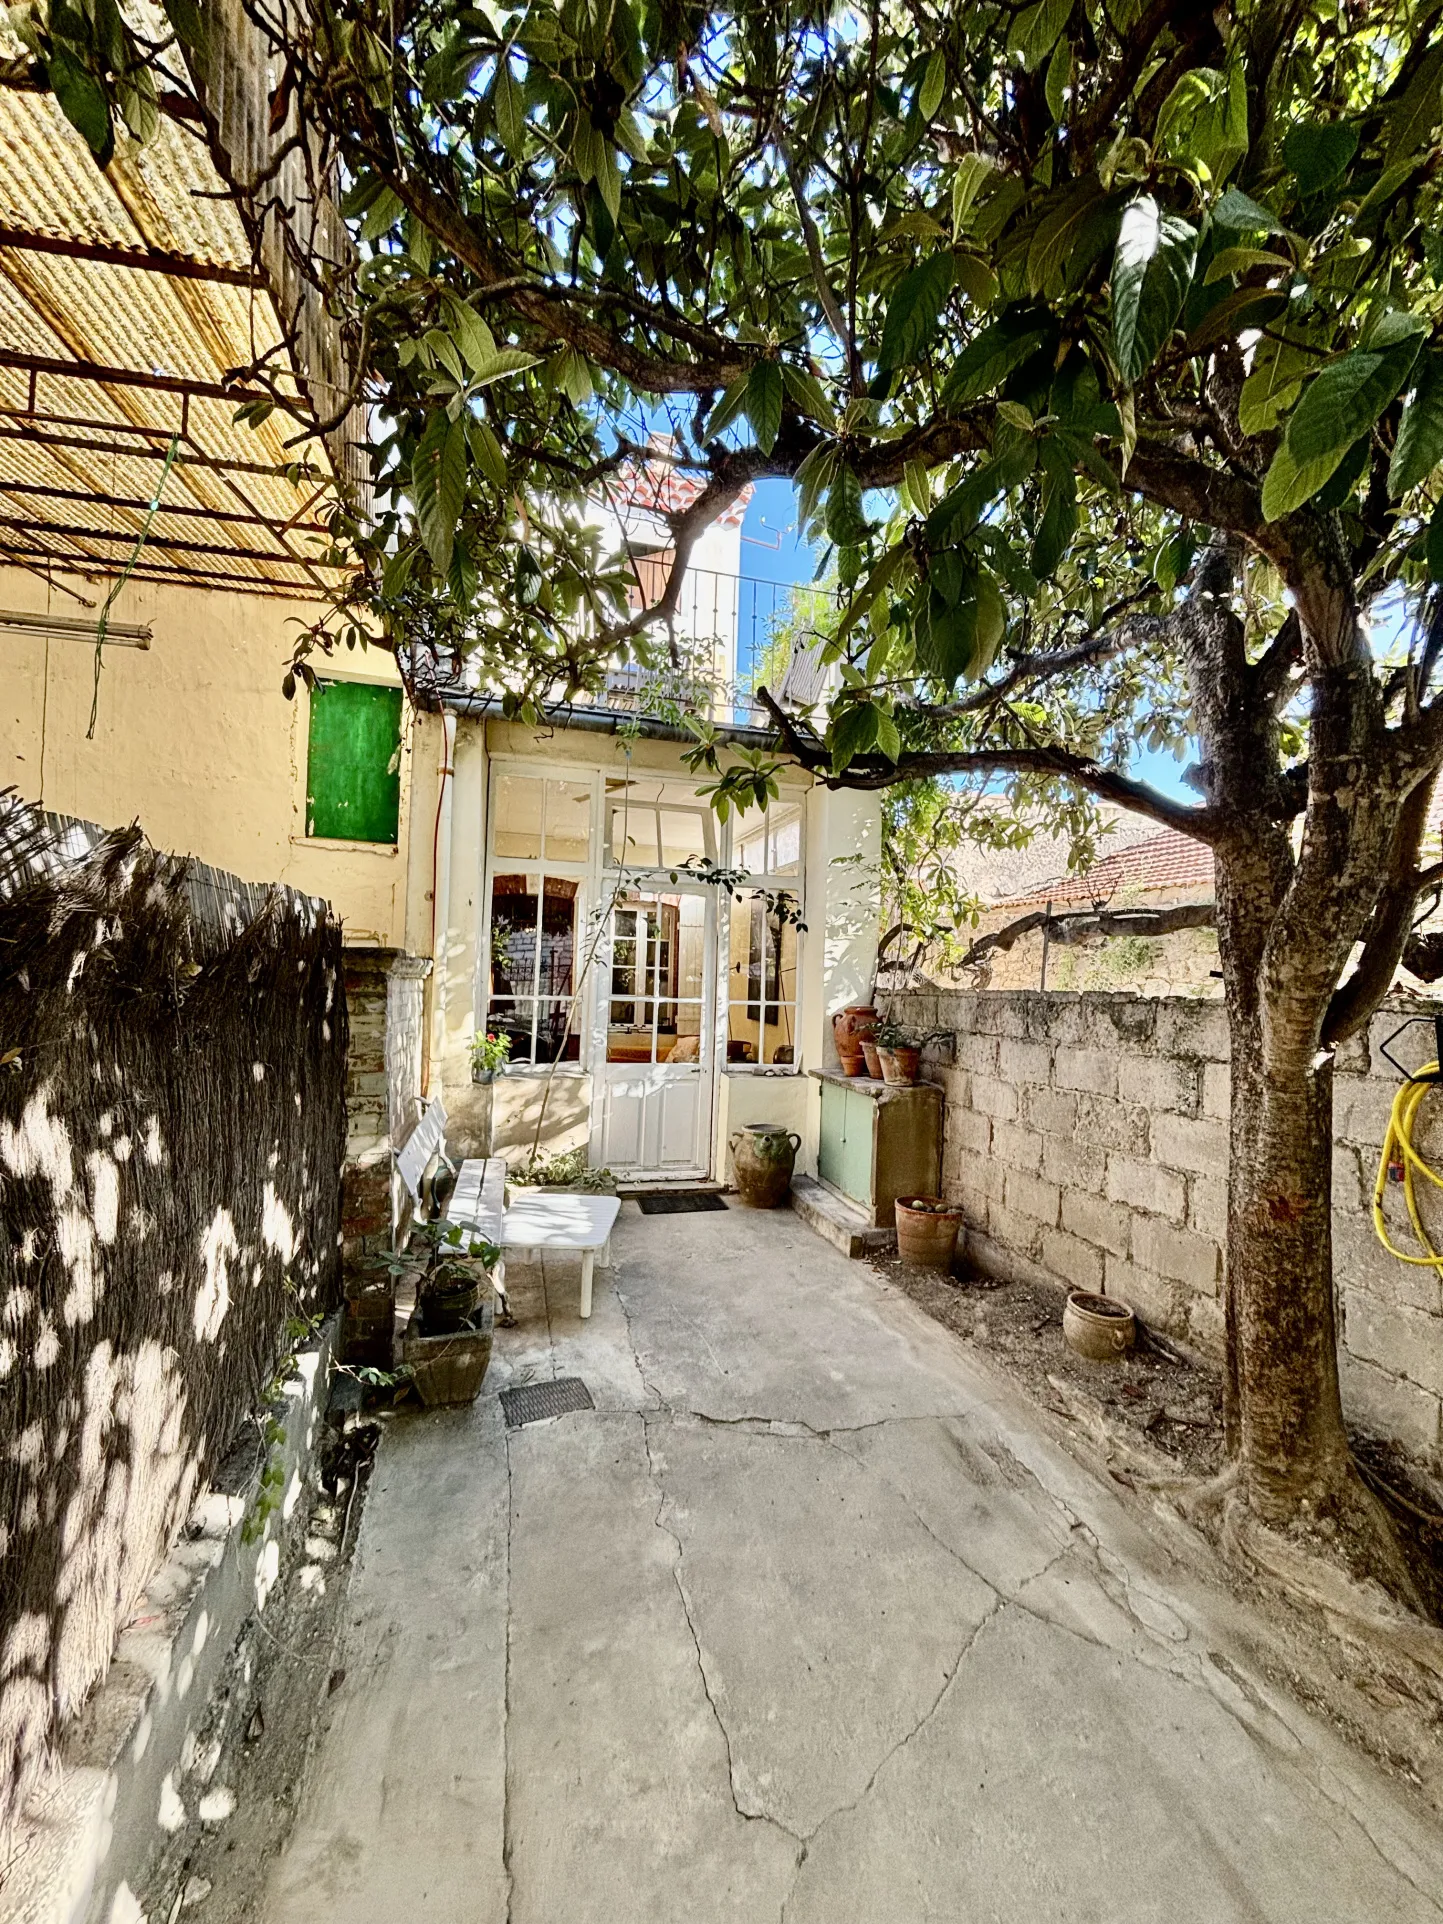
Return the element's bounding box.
[889,991,1443,1470]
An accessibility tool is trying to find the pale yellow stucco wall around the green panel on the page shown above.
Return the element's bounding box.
[0,568,417,952]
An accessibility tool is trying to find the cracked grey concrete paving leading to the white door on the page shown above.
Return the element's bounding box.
[264,1204,1443,1924]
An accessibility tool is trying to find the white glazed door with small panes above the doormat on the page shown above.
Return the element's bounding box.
[591,883,716,1181]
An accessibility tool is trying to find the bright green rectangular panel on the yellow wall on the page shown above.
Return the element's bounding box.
[306,681,400,843]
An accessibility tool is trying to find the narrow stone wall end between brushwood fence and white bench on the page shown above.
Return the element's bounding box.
[341,949,431,1254]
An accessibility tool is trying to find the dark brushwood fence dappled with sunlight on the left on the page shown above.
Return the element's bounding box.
[0,800,346,1830]
